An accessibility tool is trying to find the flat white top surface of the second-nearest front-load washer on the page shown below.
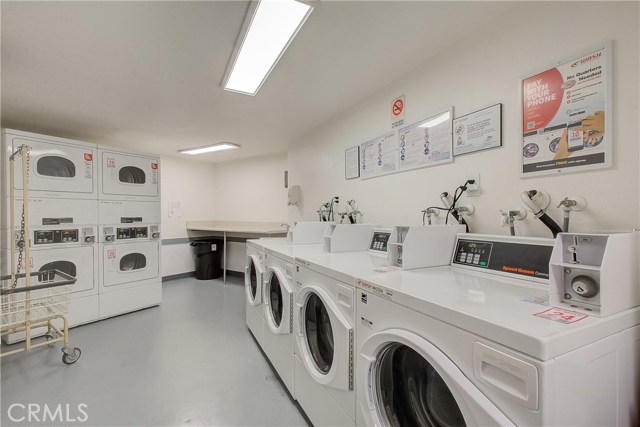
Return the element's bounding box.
[296,251,399,286]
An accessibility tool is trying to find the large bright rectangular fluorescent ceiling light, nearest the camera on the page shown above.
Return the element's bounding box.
[223,0,313,95]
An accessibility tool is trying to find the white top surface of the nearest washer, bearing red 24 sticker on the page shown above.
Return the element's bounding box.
[356,268,640,360]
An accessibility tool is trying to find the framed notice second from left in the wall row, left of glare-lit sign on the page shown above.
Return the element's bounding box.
[360,131,398,179]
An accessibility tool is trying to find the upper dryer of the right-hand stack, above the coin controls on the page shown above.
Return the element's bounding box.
[98,146,160,202]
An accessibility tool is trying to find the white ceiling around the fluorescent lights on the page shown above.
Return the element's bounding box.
[1,1,512,162]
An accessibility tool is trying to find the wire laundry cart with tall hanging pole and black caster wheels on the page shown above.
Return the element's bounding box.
[0,145,82,365]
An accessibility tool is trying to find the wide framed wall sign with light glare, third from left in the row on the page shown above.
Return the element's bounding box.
[398,108,453,171]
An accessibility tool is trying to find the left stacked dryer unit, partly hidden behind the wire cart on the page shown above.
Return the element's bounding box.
[0,129,98,342]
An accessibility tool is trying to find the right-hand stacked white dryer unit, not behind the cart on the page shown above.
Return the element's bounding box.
[98,147,162,318]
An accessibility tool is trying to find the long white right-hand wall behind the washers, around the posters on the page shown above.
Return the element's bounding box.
[288,2,640,236]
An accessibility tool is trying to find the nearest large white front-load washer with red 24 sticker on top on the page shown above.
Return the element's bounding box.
[356,235,640,426]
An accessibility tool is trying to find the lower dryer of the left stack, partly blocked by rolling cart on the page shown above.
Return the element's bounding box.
[2,199,98,342]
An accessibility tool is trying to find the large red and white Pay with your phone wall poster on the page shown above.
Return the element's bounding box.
[520,42,613,177]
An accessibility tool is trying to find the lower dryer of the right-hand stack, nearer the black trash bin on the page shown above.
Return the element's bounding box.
[98,200,162,319]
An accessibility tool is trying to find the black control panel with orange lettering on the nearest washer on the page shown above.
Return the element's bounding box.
[451,237,553,279]
